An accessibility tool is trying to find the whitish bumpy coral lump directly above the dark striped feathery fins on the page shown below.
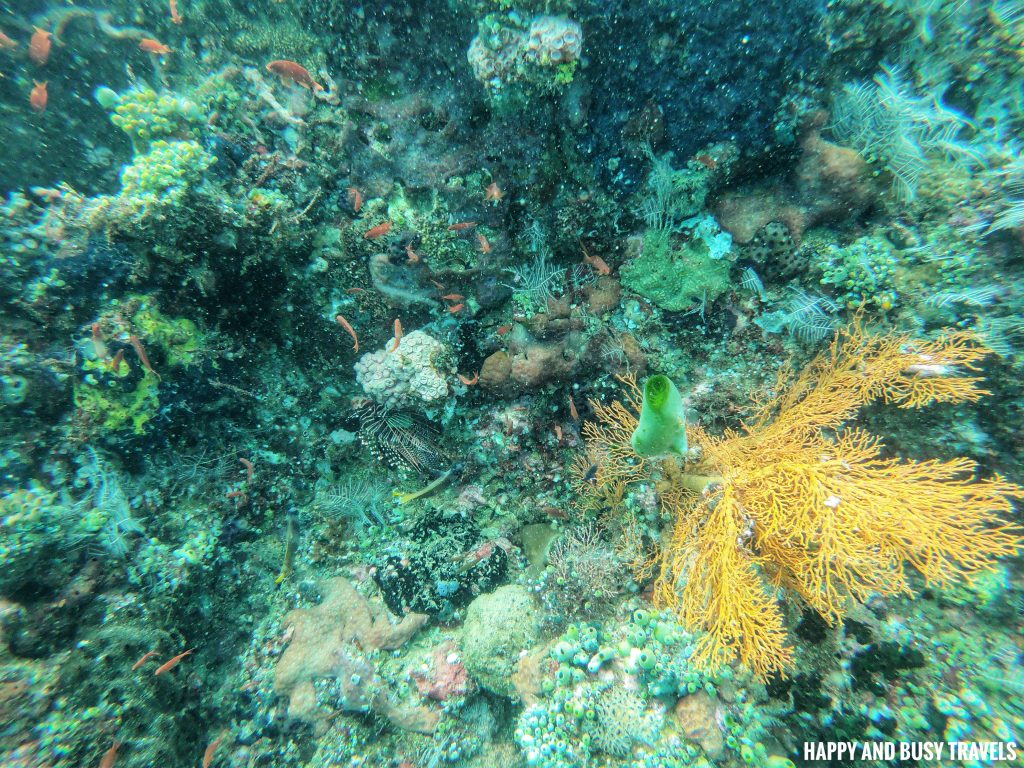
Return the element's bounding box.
[355,331,453,408]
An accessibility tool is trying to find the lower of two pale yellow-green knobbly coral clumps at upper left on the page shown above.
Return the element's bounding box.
[115,139,216,223]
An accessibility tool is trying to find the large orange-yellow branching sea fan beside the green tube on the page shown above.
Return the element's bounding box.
[581,324,1024,678]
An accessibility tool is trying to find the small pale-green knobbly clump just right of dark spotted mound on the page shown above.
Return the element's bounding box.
[818,237,899,310]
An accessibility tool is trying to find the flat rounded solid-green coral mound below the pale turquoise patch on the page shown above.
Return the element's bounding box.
[622,228,730,312]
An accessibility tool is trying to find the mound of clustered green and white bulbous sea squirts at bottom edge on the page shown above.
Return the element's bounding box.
[515,610,785,768]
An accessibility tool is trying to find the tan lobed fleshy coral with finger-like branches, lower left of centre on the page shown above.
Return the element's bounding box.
[273,577,438,733]
